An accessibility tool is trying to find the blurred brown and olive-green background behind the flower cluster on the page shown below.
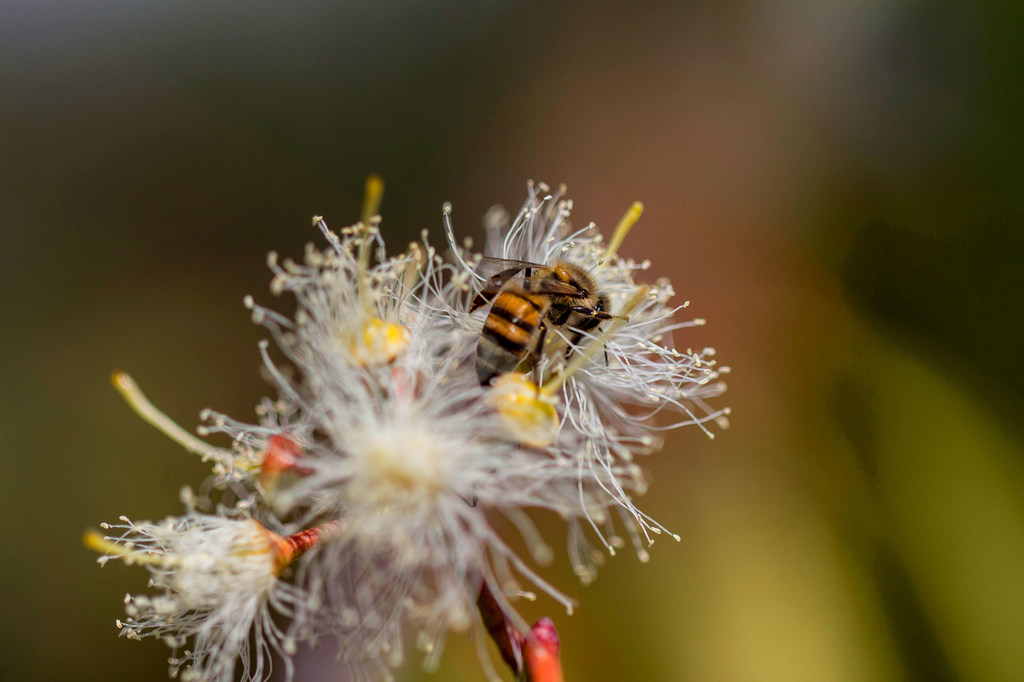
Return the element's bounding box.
[0,0,1024,682]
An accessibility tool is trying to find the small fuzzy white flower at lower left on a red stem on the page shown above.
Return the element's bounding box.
[87,512,319,681]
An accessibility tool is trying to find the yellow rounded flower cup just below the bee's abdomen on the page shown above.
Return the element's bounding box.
[488,372,558,447]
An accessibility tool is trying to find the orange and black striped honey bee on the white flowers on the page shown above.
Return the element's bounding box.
[470,258,615,386]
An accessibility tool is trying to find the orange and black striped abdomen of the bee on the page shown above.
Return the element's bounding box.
[476,291,542,385]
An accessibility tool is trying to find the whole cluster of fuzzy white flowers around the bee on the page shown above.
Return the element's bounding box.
[92,184,726,681]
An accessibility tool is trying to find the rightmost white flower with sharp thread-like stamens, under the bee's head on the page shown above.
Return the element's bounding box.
[445,183,728,579]
